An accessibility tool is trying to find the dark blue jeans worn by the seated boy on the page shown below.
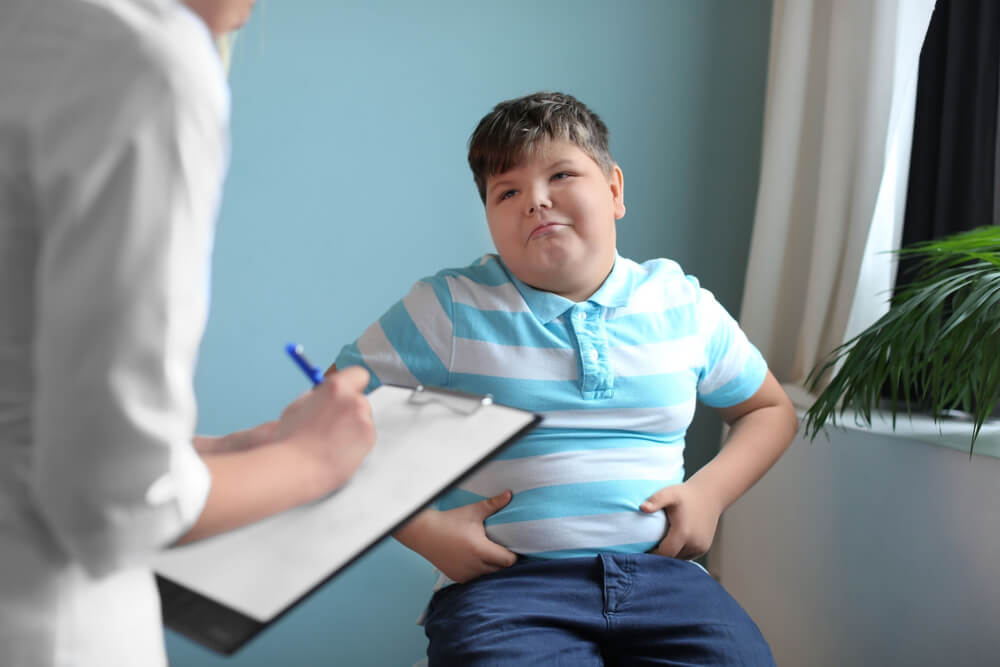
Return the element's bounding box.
[424,553,774,667]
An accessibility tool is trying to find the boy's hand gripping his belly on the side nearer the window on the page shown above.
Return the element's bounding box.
[639,480,723,560]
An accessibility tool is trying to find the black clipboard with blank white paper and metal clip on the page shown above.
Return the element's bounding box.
[153,385,542,655]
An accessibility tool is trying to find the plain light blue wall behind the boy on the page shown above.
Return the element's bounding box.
[168,0,771,667]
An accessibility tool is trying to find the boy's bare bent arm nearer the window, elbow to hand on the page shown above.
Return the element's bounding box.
[641,371,798,558]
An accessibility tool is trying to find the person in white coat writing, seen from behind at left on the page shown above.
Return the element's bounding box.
[0,0,374,667]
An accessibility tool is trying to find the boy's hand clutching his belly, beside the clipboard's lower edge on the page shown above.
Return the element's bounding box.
[394,491,517,584]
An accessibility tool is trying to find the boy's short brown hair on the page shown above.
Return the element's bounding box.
[469,92,615,202]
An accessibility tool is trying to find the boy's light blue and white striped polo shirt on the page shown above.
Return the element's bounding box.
[336,255,767,558]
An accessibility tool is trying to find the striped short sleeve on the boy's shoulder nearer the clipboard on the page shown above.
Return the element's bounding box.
[336,274,454,390]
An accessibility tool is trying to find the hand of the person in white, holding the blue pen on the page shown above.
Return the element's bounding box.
[274,366,375,495]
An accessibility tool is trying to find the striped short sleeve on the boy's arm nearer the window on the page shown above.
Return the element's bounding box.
[689,277,767,408]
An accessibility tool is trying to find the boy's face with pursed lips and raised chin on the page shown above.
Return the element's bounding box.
[486,140,625,301]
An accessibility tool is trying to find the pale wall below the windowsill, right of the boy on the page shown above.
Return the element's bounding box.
[709,410,1000,667]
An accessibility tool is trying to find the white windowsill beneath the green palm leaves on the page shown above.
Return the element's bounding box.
[783,384,1000,458]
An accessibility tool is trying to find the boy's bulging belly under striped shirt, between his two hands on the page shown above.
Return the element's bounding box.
[458,433,684,558]
